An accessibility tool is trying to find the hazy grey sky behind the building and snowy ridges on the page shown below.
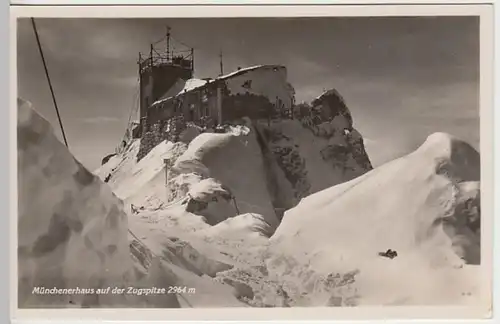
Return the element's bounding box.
[18,17,479,170]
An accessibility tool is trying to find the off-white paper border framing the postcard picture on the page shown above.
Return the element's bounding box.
[5,0,494,323]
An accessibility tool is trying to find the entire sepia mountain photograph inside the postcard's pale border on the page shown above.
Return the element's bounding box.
[16,6,491,316]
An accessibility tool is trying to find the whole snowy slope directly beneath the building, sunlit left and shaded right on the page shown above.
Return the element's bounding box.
[95,121,278,228]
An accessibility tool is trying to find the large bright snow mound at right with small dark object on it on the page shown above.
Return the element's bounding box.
[269,133,480,305]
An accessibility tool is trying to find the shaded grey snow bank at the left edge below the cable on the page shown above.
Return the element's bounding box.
[18,101,140,307]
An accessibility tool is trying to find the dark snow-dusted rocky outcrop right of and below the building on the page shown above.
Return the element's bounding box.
[257,90,372,202]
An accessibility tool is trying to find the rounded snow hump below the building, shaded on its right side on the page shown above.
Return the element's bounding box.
[168,121,278,228]
